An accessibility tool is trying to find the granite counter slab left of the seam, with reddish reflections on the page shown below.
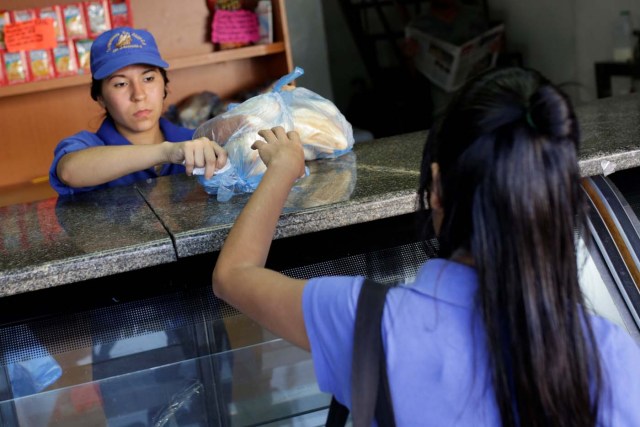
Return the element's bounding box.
[0,187,176,296]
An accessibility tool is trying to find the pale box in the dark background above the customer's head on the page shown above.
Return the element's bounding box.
[405,24,504,92]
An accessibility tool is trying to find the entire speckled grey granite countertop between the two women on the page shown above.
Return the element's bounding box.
[0,95,640,296]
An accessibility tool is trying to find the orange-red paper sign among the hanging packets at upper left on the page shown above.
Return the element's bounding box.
[4,18,57,52]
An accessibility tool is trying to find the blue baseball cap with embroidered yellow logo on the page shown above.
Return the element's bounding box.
[90,27,169,80]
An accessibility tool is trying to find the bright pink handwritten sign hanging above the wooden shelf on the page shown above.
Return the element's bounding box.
[211,10,260,43]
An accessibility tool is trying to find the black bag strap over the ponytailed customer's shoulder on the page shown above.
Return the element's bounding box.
[326,279,395,427]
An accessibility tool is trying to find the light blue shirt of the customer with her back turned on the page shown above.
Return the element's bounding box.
[303,259,640,427]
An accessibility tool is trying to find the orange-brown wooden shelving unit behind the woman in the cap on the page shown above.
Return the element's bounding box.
[0,0,293,193]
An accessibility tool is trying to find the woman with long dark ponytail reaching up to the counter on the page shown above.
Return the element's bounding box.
[213,68,640,426]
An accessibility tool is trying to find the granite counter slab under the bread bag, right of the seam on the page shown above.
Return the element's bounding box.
[138,132,426,257]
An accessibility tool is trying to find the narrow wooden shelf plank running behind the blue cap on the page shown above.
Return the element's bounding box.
[0,42,286,98]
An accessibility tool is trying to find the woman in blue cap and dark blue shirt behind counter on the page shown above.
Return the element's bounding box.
[49,27,227,195]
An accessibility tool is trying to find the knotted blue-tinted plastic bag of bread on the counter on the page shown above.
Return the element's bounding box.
[194,67,354,201]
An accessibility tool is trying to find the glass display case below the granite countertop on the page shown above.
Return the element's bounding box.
[0,177,640,427]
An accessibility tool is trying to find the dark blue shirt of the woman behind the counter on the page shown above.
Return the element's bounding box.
[49,118,195,196]
